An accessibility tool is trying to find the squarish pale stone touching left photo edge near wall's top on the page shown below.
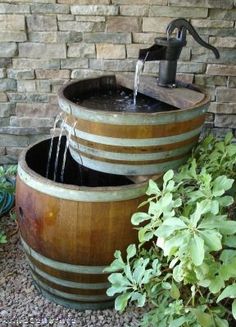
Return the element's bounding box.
[0,15,25,32]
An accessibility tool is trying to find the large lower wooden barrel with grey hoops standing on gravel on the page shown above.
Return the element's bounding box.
[16,140,155,310]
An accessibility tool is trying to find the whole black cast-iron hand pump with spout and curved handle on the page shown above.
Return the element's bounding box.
[139,18,220,87]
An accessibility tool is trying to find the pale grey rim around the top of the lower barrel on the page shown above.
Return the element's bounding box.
[18,137,159,194]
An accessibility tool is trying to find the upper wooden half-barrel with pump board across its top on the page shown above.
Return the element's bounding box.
[59,74,210,175]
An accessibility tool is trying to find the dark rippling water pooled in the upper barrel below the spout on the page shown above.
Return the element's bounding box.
[73,88,176,113]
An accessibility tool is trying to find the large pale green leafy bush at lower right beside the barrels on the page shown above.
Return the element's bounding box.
[106,135,236,327]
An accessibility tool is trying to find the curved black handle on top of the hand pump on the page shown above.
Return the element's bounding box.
[166,18,220,59]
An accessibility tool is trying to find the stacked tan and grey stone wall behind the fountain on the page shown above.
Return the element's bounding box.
[0,0,236,164]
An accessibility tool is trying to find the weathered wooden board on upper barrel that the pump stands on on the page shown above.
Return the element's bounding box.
[116,74,205,109]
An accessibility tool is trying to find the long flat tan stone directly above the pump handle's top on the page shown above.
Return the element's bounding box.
[149,6,208,18]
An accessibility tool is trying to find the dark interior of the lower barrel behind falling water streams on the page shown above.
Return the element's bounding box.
[26,136,133,187]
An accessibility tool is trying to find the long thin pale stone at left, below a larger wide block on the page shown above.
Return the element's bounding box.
[13,58,60,69]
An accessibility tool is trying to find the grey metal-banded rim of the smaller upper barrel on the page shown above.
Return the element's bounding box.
[58,74,210,118]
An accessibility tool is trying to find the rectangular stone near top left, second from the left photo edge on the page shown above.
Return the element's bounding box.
[27,15,57,32]
